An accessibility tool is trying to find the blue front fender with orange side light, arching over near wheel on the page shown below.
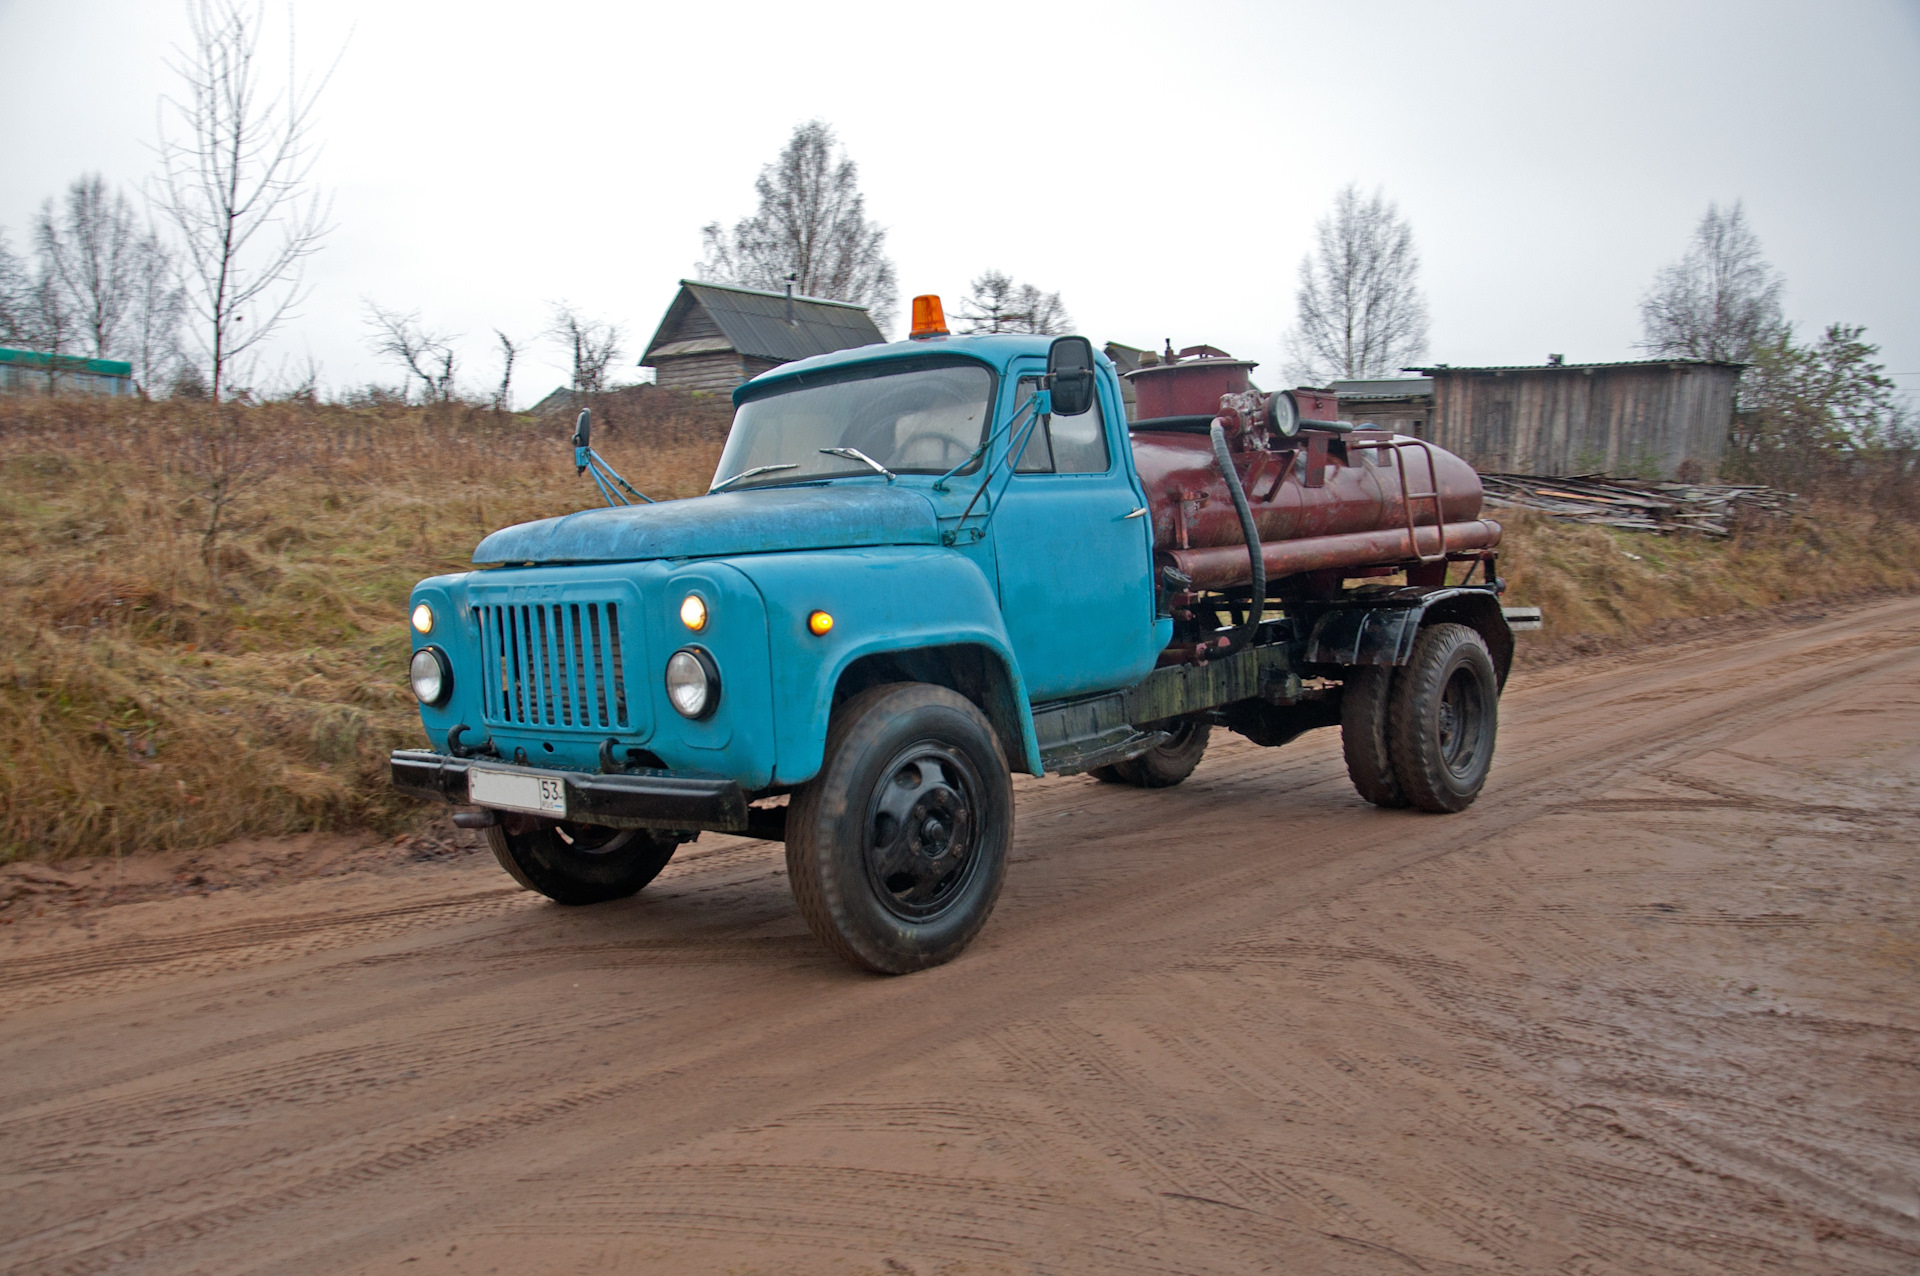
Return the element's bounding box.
[726,545,1041,785]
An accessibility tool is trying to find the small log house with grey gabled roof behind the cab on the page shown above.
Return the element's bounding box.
[639,278,887,393]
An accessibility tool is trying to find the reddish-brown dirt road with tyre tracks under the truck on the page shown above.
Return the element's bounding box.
[0,601,1920,1276]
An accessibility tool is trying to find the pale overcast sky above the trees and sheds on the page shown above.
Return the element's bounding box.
[0,0,1920,405]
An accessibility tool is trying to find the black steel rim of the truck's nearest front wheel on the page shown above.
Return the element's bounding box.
[862,741,983,921]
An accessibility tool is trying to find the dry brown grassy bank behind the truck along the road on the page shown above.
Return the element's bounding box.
[0,391,1920,860]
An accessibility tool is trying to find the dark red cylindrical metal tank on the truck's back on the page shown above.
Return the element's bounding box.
[1133,425,1500,589]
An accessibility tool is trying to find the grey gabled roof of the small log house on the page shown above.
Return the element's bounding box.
[639,278,887,366]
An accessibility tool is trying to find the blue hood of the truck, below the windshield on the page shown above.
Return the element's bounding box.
[474,482,941,564]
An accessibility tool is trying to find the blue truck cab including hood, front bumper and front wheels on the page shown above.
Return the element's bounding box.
[392,312,1503,973]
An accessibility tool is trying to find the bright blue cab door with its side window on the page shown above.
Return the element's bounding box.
[993,363,1165,702]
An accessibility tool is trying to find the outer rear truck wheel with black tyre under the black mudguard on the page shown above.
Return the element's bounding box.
[1388,624,1500,812]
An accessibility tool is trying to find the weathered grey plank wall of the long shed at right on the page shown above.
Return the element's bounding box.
[1427,363,1740,478]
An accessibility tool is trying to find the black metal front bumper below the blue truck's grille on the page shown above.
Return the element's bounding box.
[390,748,749,833]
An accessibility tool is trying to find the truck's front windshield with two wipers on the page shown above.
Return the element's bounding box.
[714,363,993,491]
